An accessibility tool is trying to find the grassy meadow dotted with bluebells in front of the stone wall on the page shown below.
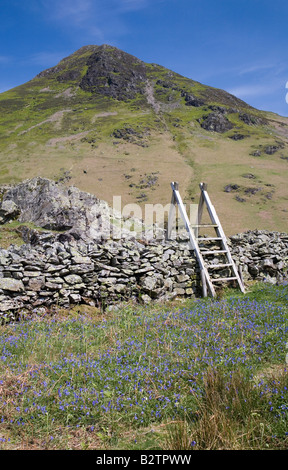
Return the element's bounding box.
[0,284,288,450]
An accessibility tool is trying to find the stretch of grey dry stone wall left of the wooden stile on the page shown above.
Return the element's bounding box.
[0,233,199,312]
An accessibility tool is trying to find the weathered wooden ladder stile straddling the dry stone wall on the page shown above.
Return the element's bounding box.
[167,182,245,297]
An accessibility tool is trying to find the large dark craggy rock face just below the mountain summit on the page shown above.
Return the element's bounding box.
[80,46,146,100]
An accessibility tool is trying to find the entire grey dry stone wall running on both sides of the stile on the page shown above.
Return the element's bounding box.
[0,229,288,318]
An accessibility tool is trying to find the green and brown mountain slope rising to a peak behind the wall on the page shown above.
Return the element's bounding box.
[0,46,288,235]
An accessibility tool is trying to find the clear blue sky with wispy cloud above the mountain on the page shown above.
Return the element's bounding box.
[0,0,288,116]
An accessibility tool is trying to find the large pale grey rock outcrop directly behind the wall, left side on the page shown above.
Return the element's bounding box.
[0,177,147,240]
